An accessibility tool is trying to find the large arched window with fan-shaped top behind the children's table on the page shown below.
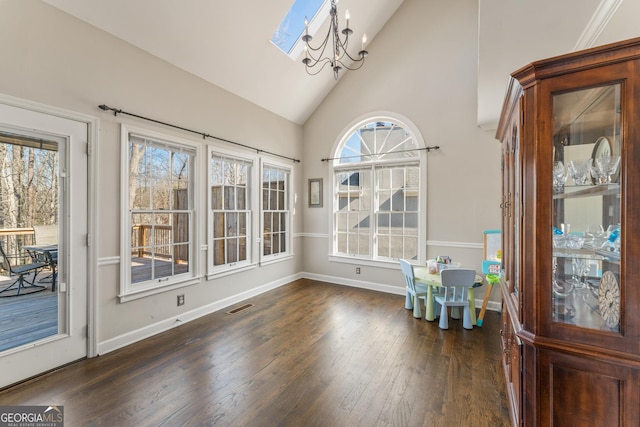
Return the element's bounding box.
[332,116,426,261]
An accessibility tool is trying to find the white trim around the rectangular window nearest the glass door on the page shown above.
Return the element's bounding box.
[118,124,201,303]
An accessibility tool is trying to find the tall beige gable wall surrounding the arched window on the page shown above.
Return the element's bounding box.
[303,0,506,301]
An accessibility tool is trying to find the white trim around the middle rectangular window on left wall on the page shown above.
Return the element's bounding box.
[206,145,262,279]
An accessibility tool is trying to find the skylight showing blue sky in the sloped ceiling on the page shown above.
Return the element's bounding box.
[271,0,326,56]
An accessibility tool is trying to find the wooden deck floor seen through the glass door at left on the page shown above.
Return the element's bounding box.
[0,276,58,352]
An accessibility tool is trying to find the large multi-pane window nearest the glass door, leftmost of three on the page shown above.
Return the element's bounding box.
[121,126,196,297]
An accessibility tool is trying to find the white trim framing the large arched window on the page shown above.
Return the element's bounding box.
[327,111,428,267]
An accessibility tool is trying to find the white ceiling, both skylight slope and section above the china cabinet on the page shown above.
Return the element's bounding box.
[43,0,640,129]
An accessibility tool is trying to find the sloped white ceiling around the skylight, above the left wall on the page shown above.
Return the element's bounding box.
[38,0,403,124]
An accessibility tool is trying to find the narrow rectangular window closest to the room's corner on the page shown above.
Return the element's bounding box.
[262,163,291,261]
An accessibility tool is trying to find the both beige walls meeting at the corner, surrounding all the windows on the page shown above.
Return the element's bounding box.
[0,0,508,347]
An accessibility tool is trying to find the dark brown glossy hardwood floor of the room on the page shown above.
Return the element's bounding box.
[0,280,510,426]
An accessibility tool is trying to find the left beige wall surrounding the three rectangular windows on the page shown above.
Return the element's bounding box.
[0,0,302,349]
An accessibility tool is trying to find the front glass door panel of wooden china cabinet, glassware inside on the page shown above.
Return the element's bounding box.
[551,84,623,332]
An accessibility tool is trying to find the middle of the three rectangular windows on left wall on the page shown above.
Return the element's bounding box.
[209,151,253,273]
